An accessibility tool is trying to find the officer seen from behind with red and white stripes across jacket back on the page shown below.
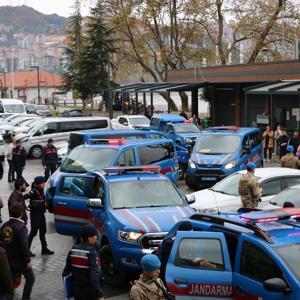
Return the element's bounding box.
[63,225,104,300]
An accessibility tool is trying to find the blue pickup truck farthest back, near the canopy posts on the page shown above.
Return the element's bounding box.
[150,114,201,148]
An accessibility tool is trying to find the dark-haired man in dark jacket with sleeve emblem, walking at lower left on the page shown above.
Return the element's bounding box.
[0,204,34,300]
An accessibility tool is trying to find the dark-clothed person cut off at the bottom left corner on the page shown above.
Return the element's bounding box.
[0,244,14,300]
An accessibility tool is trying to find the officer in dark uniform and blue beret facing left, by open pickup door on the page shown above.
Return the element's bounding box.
[28,176,54,257]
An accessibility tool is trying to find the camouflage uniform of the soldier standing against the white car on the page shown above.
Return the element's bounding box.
[239,173,262,208]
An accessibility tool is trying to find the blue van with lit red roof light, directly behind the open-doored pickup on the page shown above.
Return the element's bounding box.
[45,139,179,206]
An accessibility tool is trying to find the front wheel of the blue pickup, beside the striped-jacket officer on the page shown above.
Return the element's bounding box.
[100,245,127,286]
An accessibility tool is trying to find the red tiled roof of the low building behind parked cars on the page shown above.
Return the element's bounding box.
[0,69,63,89]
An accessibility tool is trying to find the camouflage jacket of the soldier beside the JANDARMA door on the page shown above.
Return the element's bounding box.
[129,274,166,300]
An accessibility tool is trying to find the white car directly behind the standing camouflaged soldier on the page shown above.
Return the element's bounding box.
[187,168,300,213]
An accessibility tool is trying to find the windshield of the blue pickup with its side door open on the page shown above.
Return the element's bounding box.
[109,180,184,209]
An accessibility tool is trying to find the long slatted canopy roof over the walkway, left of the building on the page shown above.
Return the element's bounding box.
[114,82,209,93]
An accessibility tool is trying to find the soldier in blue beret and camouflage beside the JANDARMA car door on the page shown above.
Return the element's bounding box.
[129,254,173,300]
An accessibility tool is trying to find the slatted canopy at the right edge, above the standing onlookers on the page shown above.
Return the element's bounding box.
[246,80,300,95]
